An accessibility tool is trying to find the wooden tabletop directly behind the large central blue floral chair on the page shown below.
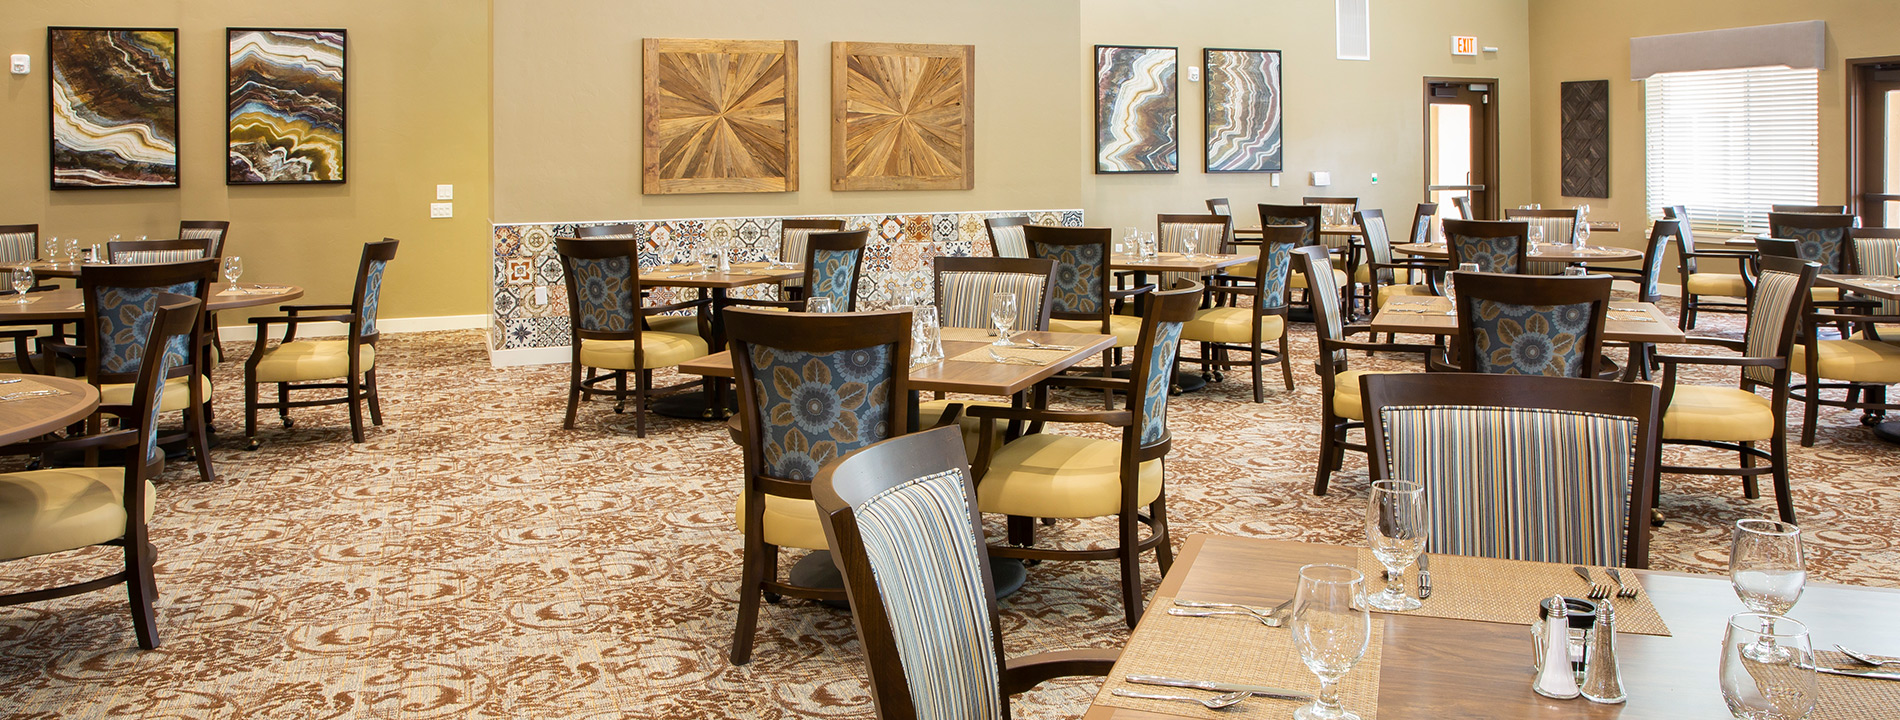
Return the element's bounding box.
[680,327,1115,395]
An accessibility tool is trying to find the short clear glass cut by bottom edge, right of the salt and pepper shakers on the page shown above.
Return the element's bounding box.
[1721,612,1816,720]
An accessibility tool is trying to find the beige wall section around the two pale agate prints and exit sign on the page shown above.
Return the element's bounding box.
[1072,0,1530,230]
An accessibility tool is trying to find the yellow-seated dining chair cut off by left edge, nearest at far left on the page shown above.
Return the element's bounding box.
[0,293,203,650]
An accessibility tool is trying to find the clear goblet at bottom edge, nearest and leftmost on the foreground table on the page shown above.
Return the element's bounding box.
[1288,564,1372,720]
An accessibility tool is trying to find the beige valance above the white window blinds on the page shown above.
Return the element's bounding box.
[1630,21,1828,80]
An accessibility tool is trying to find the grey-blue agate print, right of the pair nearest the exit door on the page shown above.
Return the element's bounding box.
[1203,47,1284,173]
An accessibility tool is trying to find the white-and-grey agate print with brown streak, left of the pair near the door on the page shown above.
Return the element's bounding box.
[1094,46,1180,173]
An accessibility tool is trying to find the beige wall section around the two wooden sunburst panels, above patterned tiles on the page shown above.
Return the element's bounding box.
[494,0,1087,222]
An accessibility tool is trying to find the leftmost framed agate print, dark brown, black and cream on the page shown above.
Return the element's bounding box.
[46,27,179,190]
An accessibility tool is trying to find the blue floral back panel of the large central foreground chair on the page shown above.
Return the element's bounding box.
[749,344,895,483]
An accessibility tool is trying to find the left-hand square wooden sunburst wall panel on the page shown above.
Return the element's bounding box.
[642,38,798,196]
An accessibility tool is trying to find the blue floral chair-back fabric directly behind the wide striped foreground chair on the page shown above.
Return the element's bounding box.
[1469,298,1592,378]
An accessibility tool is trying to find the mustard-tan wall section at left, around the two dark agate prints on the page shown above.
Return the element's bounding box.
[0,0,488,325]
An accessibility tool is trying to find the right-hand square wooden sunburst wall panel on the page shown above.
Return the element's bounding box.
[832,42,977,190]
